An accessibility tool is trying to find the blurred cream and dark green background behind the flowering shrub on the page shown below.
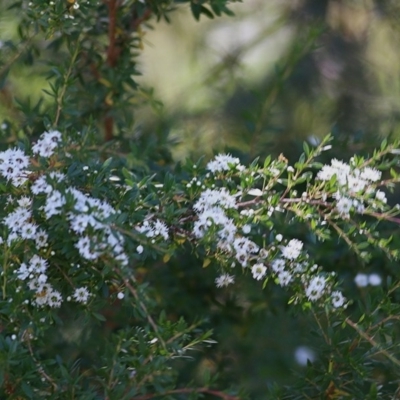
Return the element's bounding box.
[0,0,400,399]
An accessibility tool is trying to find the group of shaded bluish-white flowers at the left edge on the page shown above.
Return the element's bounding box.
[0,131,128,307]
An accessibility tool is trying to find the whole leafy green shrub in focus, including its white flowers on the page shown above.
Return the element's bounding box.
[0,0,400,400]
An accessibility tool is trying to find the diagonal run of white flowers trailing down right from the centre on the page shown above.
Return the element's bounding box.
[193,183,345,308]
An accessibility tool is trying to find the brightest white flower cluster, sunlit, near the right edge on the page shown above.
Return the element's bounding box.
[317,159,387,218]
